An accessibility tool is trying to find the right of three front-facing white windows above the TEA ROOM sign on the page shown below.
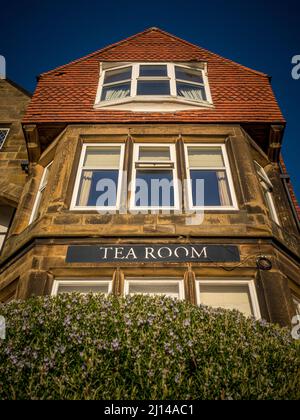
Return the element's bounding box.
[185,144,237,210]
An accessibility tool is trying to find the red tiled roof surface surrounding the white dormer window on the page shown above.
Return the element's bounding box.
[23,28,285,124]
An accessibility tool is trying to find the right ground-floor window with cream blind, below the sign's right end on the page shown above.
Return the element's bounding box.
[196,279,261,319]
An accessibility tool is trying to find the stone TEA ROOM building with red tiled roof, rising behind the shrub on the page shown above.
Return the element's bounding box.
[0,28,300,325]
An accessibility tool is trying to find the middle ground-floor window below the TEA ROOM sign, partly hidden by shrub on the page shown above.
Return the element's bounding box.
[124,278,184,299]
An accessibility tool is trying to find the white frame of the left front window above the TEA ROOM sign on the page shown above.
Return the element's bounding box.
[70,143,125,211]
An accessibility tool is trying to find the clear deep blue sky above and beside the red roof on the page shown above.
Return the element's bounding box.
[0,0,300,199]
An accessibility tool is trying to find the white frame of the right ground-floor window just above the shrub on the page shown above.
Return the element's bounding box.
[196,278,261,319]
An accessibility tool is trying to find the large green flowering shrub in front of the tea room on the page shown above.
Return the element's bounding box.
[0,294,300,400]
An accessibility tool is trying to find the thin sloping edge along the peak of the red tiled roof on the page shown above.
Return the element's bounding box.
[39,26,269,78]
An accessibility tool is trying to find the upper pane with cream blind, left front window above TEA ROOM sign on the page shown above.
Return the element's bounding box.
[83,146,121,169]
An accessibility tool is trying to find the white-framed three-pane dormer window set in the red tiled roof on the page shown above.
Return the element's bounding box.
[95,63,212,112]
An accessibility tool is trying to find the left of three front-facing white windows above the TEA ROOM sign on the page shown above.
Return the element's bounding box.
[71,143,124,210]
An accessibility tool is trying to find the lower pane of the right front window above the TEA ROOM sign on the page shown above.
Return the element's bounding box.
[190,170,232,206]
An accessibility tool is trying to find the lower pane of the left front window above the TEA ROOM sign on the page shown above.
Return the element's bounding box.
[76,170,119,206]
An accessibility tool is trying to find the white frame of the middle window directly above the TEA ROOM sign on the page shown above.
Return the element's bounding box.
[130,143,180,212]
